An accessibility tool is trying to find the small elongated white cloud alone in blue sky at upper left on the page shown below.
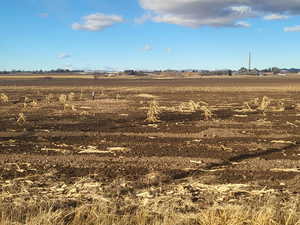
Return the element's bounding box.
[72,13,124,31]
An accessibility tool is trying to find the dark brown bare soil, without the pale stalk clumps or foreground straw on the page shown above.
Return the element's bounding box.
[0,78,300,194]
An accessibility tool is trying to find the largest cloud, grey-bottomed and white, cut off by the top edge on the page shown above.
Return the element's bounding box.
[139,0,300,28]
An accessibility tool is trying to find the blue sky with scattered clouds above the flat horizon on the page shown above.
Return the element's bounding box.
[0,0,300,70]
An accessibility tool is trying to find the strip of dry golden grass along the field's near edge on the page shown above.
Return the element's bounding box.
[0,201,300,225]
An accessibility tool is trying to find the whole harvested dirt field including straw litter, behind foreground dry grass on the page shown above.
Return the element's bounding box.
[0,77,300,223]
